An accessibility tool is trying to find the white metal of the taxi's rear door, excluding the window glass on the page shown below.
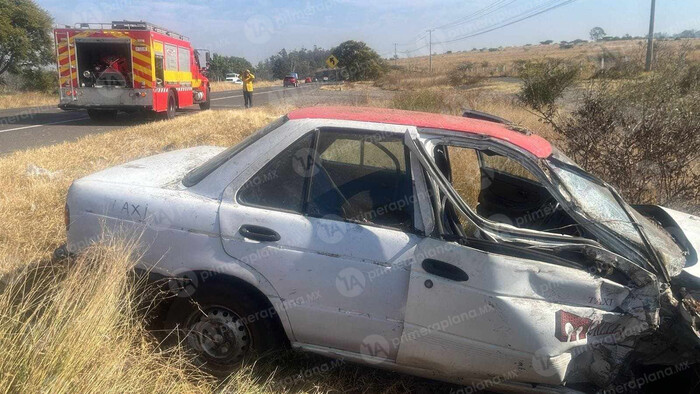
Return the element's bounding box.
[220,121,418,358]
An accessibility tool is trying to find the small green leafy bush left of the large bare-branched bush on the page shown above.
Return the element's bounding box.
[517,60,580,118]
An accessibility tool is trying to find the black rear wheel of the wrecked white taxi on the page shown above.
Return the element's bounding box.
[164,279,285,378]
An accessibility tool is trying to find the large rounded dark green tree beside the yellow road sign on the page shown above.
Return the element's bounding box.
[332,40,388,81]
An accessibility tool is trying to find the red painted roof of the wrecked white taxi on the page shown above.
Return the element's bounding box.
[287,107,552,158]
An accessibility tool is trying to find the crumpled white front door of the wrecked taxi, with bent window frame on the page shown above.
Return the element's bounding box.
[397,132,660,384]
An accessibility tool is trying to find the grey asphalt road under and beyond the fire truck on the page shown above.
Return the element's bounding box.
[0,84,318,156]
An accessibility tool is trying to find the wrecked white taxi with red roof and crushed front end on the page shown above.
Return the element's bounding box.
[66,107,700,391]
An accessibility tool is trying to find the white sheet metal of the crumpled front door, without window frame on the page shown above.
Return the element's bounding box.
[397,238,630,384]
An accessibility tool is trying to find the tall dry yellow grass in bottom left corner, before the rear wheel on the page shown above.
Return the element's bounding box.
[0,242,216,393]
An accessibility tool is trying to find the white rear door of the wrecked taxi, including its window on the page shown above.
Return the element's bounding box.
[219,125,420,360]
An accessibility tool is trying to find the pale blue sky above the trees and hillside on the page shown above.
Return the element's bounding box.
[37,0,700,63]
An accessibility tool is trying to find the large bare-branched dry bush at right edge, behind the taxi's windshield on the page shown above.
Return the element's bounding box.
[557,61,700,213]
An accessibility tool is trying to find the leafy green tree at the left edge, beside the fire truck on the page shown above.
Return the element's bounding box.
[0,0,54,75]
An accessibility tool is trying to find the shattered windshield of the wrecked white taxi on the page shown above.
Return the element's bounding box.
[549,161,685,276]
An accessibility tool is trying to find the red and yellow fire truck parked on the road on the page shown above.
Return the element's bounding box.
[54,21,211,120]
